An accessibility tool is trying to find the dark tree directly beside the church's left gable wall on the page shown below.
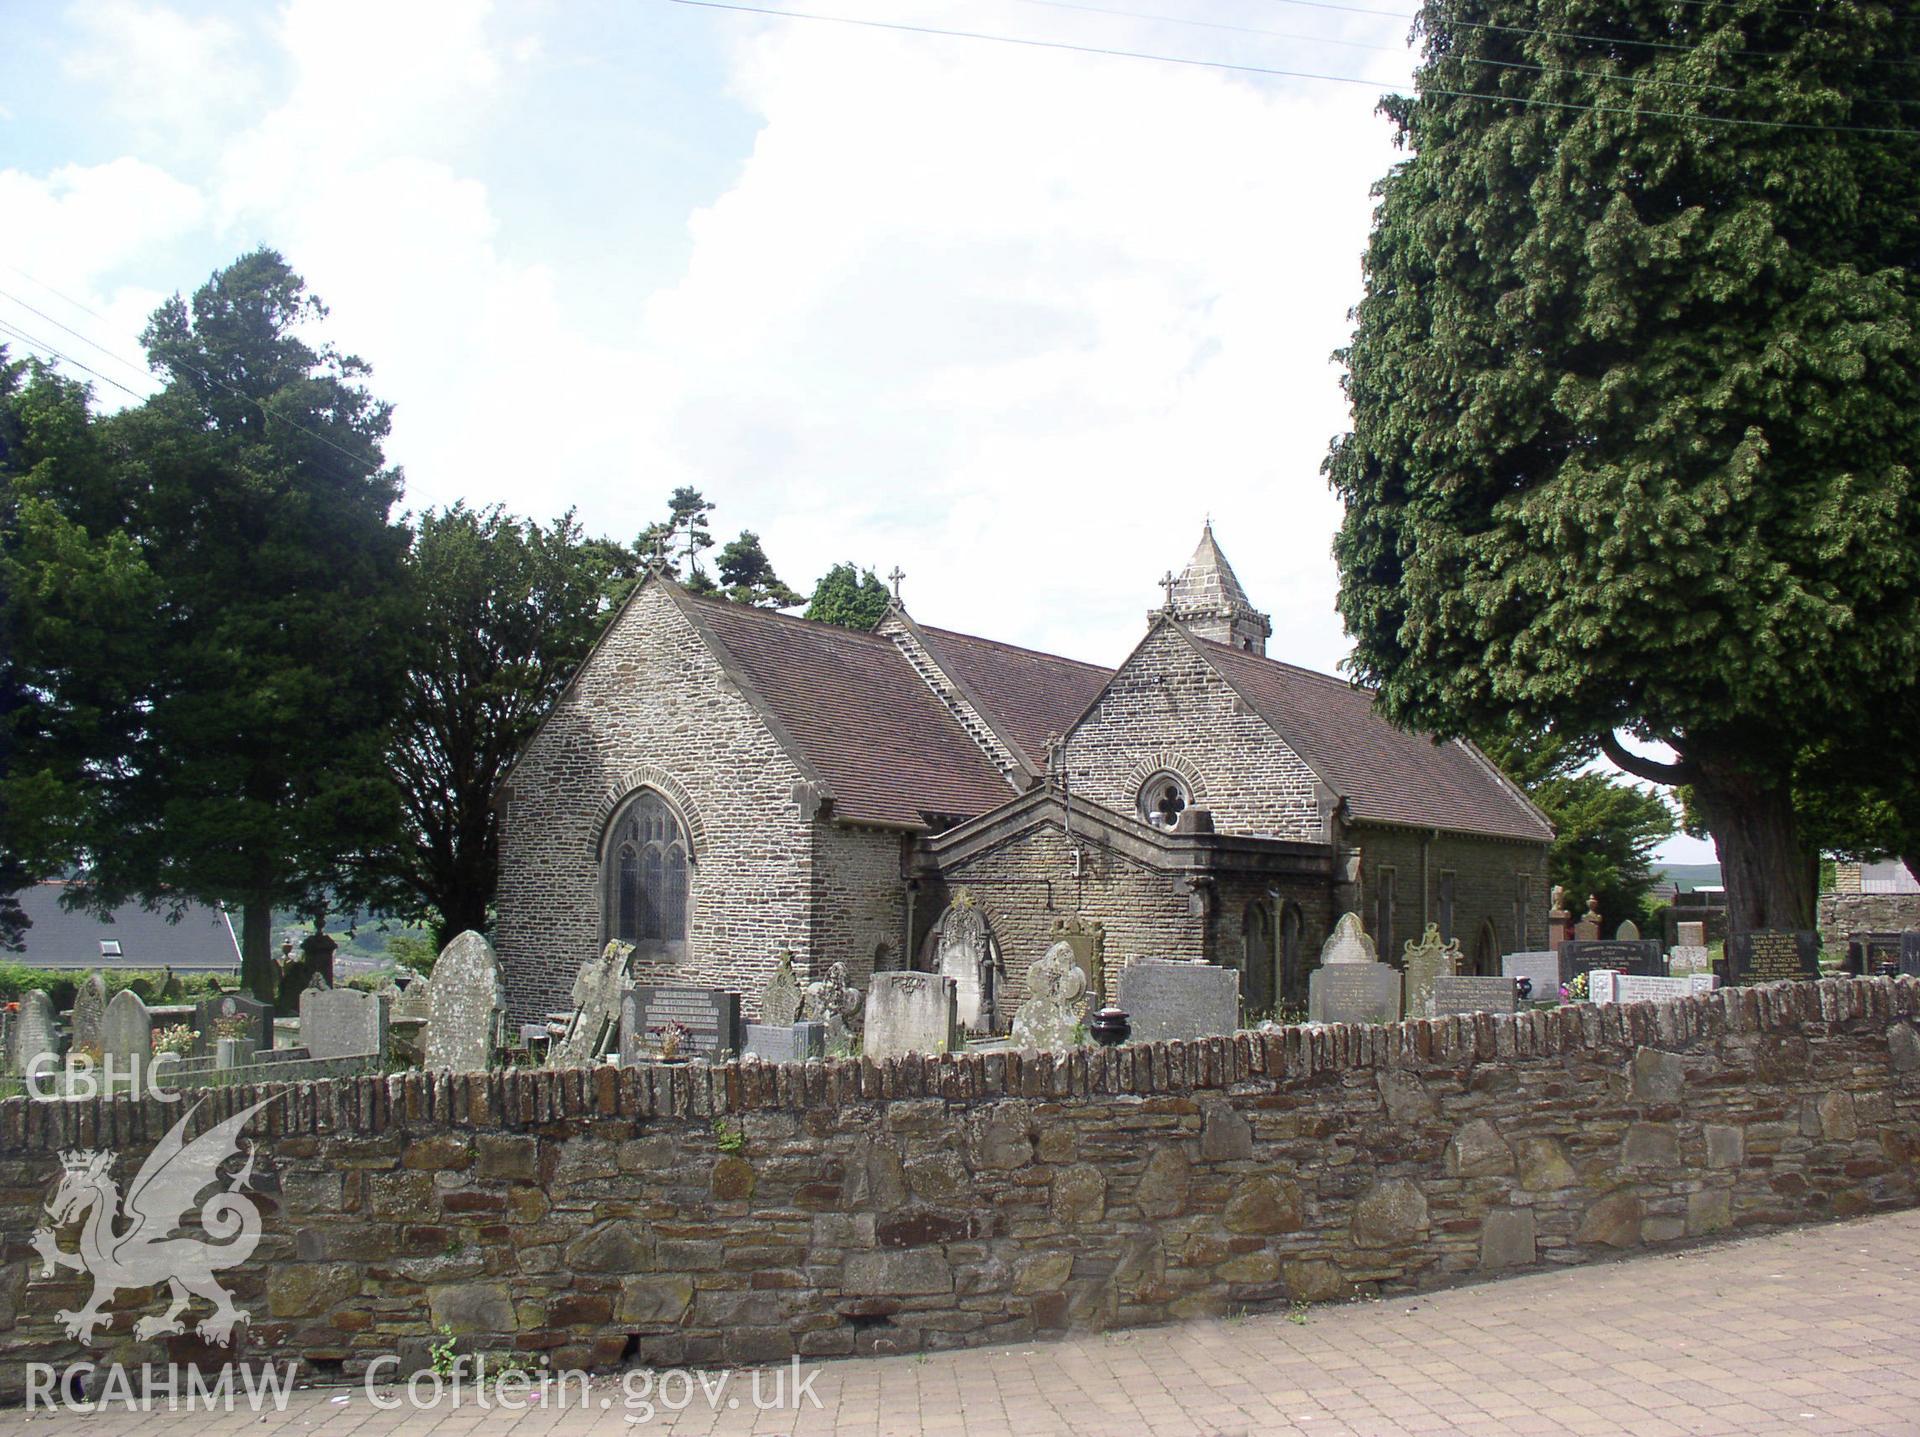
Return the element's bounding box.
[365,503,637,951]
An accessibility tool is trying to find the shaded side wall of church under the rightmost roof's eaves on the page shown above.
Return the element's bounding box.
[1344,824,1551,972]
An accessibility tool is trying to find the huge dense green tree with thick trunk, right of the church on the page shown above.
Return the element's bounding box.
[1327,0,1920,930]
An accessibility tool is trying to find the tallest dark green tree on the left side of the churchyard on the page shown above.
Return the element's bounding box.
[8,250,407,999]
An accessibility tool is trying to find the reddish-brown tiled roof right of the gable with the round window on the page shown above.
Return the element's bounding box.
[1194,638,1553,841]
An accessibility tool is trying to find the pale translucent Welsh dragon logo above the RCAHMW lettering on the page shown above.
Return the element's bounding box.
[33,1099,275,1347]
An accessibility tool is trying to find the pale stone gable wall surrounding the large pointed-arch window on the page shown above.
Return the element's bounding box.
[497,586,814,1018]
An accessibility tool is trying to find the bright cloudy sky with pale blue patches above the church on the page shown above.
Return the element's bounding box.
[0,0,1711,861]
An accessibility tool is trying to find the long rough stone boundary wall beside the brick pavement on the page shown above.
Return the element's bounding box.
[0,978,1920,1397]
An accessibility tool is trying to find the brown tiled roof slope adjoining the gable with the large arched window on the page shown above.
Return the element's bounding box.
[684,594,1014,824]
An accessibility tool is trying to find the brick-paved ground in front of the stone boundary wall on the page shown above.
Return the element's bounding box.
[18,1212,1920,1437]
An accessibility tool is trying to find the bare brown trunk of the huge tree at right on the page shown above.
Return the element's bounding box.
[1690,753,1818,934]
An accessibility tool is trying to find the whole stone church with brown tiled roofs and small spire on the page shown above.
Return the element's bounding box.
[499,526,1551,1030]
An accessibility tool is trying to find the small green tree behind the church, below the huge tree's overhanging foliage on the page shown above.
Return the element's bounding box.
[1476,728,1678,926]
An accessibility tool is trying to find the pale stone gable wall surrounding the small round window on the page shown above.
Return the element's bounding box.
[1066,624,1327,841]
